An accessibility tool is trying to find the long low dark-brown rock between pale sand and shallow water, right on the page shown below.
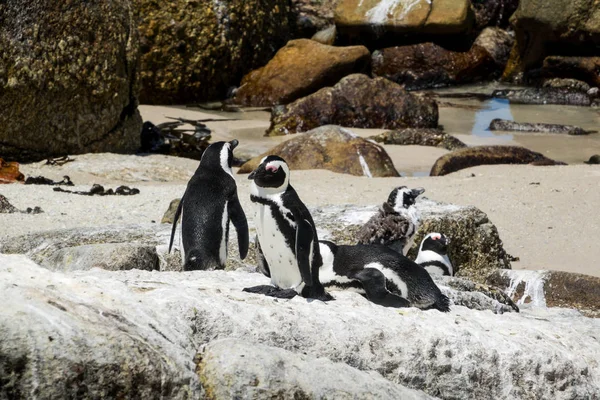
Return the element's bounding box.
[429,146,564,176]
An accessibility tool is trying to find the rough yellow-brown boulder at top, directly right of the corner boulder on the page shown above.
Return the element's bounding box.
[133,0,291,104]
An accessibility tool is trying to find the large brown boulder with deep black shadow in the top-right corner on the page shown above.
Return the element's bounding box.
[504,0,600,81]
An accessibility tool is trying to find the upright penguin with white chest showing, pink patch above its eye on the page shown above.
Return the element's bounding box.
[244,155,332,301]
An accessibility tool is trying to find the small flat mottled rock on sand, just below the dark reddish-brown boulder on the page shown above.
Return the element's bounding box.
[371,128,467,150]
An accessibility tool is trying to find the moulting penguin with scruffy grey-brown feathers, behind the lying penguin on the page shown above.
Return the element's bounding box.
[357,186,425,255]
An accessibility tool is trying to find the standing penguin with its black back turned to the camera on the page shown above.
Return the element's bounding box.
[169,139,248,271]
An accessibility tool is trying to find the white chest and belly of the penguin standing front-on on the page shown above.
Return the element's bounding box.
[255,204,304,292]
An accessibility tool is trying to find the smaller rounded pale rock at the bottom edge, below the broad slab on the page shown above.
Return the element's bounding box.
[197,339,433,400]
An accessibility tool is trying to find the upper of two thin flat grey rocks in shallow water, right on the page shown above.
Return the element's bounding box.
[492,87,593,106]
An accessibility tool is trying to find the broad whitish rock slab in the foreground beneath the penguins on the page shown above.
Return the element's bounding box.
[0,255,600,400]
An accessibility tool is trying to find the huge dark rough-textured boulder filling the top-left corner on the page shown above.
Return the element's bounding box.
[0,0,142,161]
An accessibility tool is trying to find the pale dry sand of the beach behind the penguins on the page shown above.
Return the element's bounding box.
[0,146,600,276]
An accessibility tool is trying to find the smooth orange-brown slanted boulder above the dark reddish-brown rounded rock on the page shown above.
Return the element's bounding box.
[233,39,371,106]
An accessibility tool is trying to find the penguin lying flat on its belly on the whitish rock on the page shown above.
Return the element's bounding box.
[319,241,450,312]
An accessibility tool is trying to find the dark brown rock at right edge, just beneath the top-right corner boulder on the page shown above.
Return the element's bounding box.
[542,55,600,86]
